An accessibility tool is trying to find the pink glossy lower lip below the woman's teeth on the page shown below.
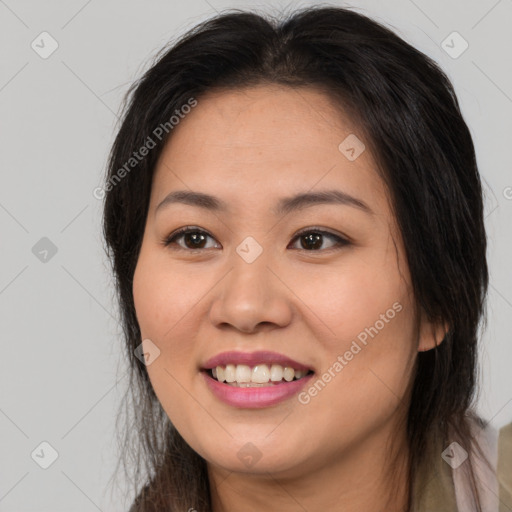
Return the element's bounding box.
[201,371,314,409]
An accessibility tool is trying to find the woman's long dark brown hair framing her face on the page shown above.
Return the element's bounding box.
[102,7,488,512]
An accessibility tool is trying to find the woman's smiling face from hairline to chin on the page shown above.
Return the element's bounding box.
[133,86,442,475]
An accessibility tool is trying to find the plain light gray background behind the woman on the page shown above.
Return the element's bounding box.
[0,0,512,512]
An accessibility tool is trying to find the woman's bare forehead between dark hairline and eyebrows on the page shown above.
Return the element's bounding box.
[152,85,385,218]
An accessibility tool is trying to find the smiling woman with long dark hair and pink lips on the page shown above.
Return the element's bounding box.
[104,7,512,512]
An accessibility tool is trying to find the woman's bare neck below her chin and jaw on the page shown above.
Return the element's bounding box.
[208,424,409,512]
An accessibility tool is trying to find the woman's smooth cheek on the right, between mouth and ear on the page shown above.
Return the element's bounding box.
[298,253,417,414]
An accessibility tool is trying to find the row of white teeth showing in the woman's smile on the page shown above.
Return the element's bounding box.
[212,364,308,387]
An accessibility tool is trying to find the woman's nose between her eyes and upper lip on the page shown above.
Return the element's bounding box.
[210,251,293,333]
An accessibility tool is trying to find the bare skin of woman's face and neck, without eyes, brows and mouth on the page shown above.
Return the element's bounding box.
[133,85,444,512]
